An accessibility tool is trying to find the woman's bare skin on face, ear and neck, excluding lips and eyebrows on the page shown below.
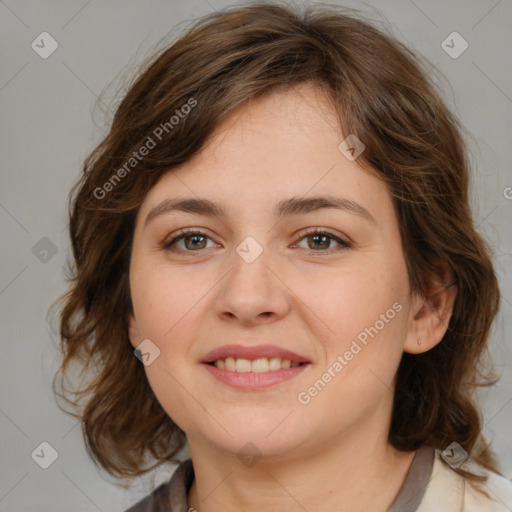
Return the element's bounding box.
[129,84,454,512]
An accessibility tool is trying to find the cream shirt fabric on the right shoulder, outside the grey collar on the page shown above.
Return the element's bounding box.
[417,449,512,512]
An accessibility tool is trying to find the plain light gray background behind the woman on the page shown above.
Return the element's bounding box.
[0,0,512,512]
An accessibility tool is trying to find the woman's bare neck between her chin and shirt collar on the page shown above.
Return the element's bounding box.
[188,406,415,512]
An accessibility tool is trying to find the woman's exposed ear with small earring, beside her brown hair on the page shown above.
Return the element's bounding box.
[404,264,457,354]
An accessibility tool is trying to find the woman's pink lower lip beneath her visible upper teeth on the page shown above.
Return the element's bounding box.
[203,363,310,391]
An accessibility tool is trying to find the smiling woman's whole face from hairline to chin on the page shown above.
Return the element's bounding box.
[130,84,420,455]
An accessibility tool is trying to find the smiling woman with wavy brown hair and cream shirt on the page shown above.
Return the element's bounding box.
[56,3,512,512]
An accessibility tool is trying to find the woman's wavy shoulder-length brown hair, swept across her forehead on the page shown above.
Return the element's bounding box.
[49,3,501,494]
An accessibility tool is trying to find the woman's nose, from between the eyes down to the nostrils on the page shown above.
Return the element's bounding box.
[213,245,292,325]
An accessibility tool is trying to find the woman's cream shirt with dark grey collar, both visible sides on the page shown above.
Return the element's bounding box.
[125,445,512,512]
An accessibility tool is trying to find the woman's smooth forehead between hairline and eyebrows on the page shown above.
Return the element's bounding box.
[137,84,391,224]
